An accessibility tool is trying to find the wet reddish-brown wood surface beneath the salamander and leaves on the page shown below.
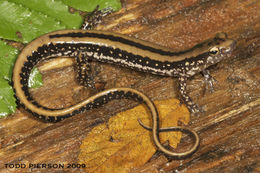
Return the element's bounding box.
[0,0,260,172]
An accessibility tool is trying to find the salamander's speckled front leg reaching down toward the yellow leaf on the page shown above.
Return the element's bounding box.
[178,76,202,114]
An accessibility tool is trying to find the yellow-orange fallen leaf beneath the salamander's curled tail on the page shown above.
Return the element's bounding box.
[79,99,189,173]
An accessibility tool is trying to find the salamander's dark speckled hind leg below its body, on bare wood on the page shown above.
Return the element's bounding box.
[76,52,96,89]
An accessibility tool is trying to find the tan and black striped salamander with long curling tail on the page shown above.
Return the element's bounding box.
[12,30,235,156]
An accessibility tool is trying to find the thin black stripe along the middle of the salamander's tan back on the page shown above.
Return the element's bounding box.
[49,32,205,56]
